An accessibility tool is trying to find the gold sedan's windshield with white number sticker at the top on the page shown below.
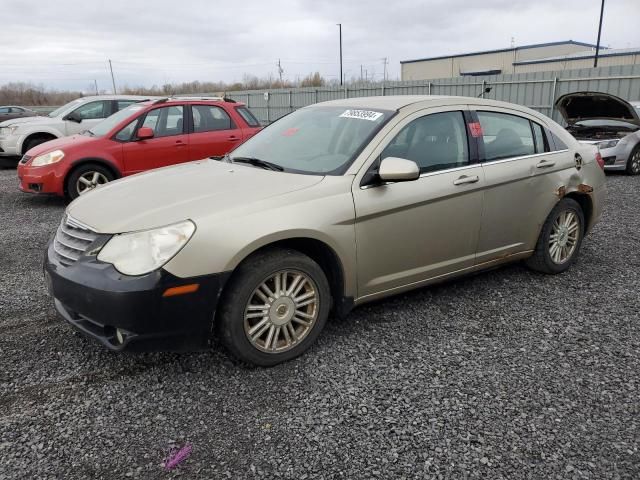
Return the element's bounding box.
[231,107,394,175]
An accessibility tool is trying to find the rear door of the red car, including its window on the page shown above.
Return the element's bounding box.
[189,104,243,160]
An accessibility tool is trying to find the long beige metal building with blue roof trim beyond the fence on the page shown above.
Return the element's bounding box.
[400,40,640,80]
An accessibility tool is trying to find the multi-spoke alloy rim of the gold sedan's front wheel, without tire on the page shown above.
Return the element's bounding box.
[244,270,320,353]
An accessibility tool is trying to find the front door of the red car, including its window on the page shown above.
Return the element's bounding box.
[122,105,189,174]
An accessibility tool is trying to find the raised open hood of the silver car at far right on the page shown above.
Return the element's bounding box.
[555,92,640,126]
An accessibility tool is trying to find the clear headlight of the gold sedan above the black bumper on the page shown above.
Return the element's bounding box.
[98,220,196,275]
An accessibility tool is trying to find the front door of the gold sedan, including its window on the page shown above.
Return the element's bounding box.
[353,107,484,298]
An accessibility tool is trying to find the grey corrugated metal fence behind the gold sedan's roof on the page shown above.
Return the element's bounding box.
[218,65,640,125]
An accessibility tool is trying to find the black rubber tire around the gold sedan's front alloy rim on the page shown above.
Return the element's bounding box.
[216,248,331,367]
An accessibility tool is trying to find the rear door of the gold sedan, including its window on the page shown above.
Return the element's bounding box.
[475,106,575,264]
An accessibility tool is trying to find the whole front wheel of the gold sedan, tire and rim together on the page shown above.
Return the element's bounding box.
[217,249,331,367]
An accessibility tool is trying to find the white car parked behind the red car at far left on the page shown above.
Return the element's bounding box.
[0,95,151,157]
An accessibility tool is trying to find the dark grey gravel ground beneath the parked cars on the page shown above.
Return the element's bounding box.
[0,170,640,479]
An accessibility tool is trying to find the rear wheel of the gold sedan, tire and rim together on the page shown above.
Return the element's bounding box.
[526,198,584,274]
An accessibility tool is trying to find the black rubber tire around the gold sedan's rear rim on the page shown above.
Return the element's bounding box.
[525,198,585,274]
